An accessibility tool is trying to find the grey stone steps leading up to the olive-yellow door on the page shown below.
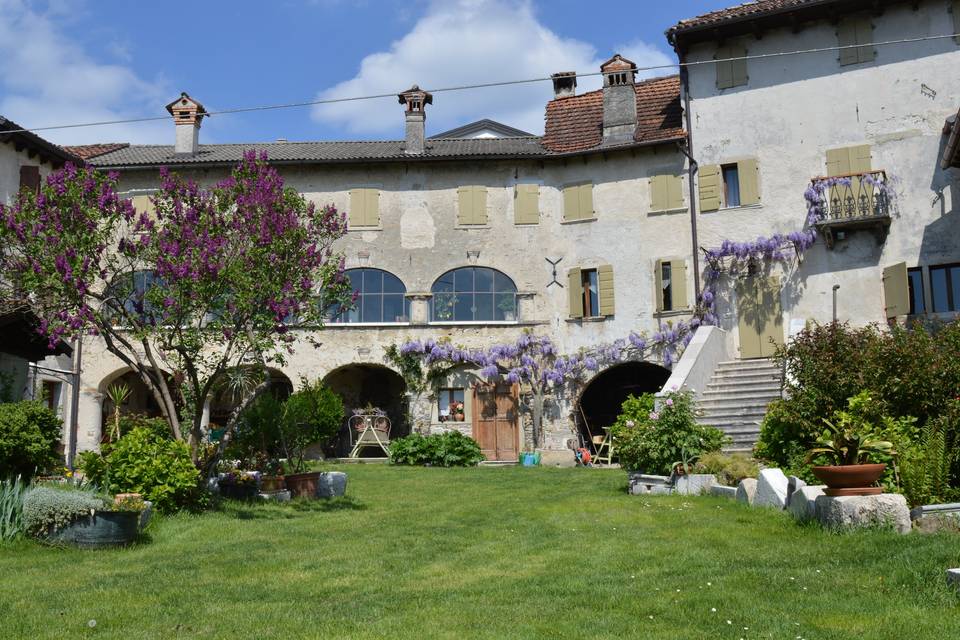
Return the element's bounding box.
[698,358,782,453]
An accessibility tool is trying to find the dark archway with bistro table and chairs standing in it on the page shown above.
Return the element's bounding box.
[323,363,410,457]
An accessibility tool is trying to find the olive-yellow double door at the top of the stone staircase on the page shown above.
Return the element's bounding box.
[737,276,783,358]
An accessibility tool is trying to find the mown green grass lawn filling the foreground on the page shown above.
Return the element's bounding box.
[0,465,960,640]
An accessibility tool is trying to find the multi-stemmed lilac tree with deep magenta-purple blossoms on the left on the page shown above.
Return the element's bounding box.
[0,151,349,461]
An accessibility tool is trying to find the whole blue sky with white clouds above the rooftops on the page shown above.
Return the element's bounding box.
[0,0,736,144]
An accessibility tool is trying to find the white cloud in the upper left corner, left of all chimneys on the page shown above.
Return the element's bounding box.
[0,0,173,144]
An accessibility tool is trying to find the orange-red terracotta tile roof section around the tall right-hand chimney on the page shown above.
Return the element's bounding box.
[542,76,685,153]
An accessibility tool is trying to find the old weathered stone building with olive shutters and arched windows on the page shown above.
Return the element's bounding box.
[54,0,960,460]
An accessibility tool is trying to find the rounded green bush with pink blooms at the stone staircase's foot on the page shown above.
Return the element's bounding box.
[611,391,726,475]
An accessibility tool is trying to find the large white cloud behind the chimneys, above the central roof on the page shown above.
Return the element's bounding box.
[313,0,673,137]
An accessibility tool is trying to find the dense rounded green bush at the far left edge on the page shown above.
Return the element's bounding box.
[0,400,63,478]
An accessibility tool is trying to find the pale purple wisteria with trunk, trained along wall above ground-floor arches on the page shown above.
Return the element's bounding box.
[388,319,699,447]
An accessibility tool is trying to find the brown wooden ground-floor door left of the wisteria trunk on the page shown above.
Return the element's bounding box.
[473,383,520,461]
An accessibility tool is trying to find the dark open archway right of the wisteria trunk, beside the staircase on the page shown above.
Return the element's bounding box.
[574,362,670,446]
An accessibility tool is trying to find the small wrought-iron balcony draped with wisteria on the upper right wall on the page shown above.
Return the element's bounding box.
[810,170,892,249]
